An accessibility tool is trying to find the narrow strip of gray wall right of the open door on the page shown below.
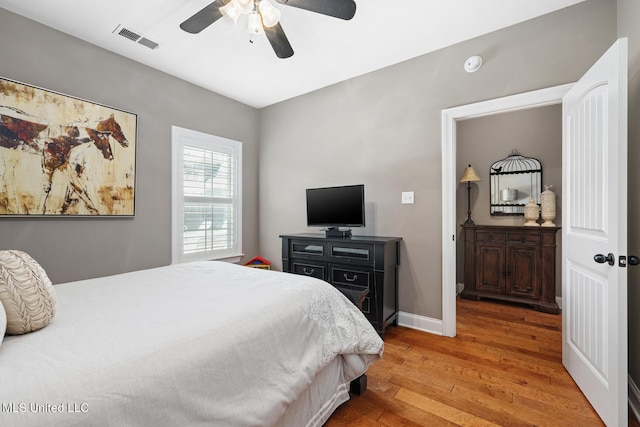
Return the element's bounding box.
[618,0,640,409]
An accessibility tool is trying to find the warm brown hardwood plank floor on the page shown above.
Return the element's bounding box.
[326,299,640,427]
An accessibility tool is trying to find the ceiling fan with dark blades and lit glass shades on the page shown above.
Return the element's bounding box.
[180,0,356,58]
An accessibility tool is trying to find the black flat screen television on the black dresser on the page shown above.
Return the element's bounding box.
[307,184,365,237]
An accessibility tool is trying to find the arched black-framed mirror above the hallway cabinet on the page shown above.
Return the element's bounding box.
[489,150,542,215]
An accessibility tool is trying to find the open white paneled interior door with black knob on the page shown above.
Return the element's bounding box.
[562,38,628,426]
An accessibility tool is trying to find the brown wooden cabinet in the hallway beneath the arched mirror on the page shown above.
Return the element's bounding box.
[461,225,560,314]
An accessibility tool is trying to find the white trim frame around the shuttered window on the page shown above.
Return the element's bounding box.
[171,126,243,264]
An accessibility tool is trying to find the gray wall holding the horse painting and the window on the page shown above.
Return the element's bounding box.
[0,9,259,283]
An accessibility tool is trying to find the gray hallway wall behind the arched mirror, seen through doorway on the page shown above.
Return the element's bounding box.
[456,104,562,296]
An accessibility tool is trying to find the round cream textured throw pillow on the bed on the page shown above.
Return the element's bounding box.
[0,250,56,335]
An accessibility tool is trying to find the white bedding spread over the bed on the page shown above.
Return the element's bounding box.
[0,261,383,427]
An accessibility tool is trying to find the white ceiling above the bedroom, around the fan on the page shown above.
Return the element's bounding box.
[0,0,584,108]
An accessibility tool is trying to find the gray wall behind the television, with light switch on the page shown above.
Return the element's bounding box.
[259,0,616,319]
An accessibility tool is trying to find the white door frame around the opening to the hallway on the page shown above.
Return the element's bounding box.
[442,83,573,337]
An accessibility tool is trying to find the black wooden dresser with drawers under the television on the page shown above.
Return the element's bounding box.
[280,234,402,338]
